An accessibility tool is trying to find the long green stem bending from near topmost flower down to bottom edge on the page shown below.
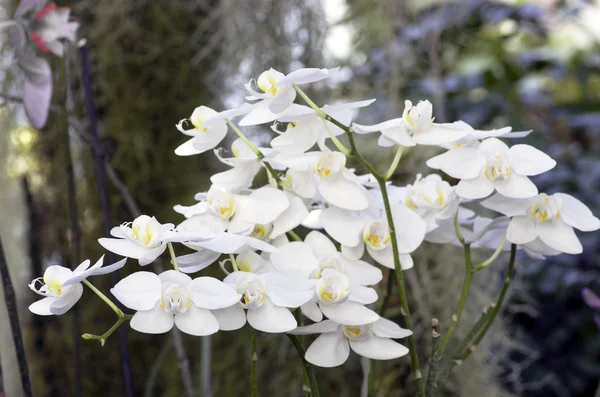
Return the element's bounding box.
[294,85,425,397]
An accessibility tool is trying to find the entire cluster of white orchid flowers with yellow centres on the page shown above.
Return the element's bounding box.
[30,65,600,367]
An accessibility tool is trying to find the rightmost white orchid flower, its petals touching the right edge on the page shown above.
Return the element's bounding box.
[481,193,600,255]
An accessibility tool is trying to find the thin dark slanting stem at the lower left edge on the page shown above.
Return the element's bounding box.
[0,240,33,397]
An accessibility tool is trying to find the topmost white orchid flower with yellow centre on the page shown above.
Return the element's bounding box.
[240,68,338,126]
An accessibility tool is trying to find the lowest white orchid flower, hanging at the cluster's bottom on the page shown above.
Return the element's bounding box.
[289,318,412,368]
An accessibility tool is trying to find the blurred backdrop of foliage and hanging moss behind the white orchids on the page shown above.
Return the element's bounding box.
[0,0,600,397]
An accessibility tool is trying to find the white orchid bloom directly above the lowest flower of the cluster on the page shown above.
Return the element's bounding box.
[270,231,383,325]
